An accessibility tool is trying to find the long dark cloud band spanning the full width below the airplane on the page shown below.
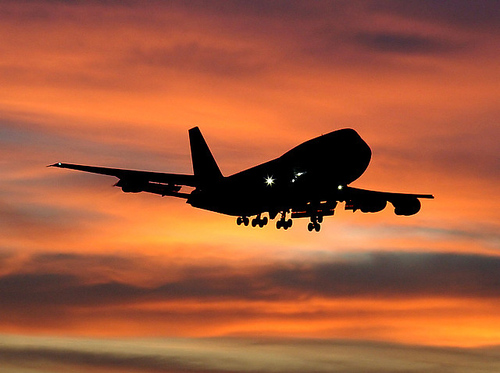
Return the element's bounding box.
[0,253,500,310]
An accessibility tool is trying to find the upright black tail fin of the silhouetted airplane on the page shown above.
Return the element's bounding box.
[189,127,223,185]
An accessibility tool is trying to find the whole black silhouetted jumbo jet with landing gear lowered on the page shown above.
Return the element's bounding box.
[48,127,434,232]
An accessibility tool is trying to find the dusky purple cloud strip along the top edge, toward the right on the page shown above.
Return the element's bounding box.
[172,0,500,33]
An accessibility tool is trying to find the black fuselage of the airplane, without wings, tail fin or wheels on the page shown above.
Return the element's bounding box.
[187,129,371,216]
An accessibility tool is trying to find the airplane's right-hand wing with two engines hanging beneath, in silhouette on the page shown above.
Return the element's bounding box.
[340,187,434,216]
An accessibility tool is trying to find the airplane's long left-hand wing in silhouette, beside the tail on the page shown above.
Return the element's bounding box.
[48,162,197,198]
